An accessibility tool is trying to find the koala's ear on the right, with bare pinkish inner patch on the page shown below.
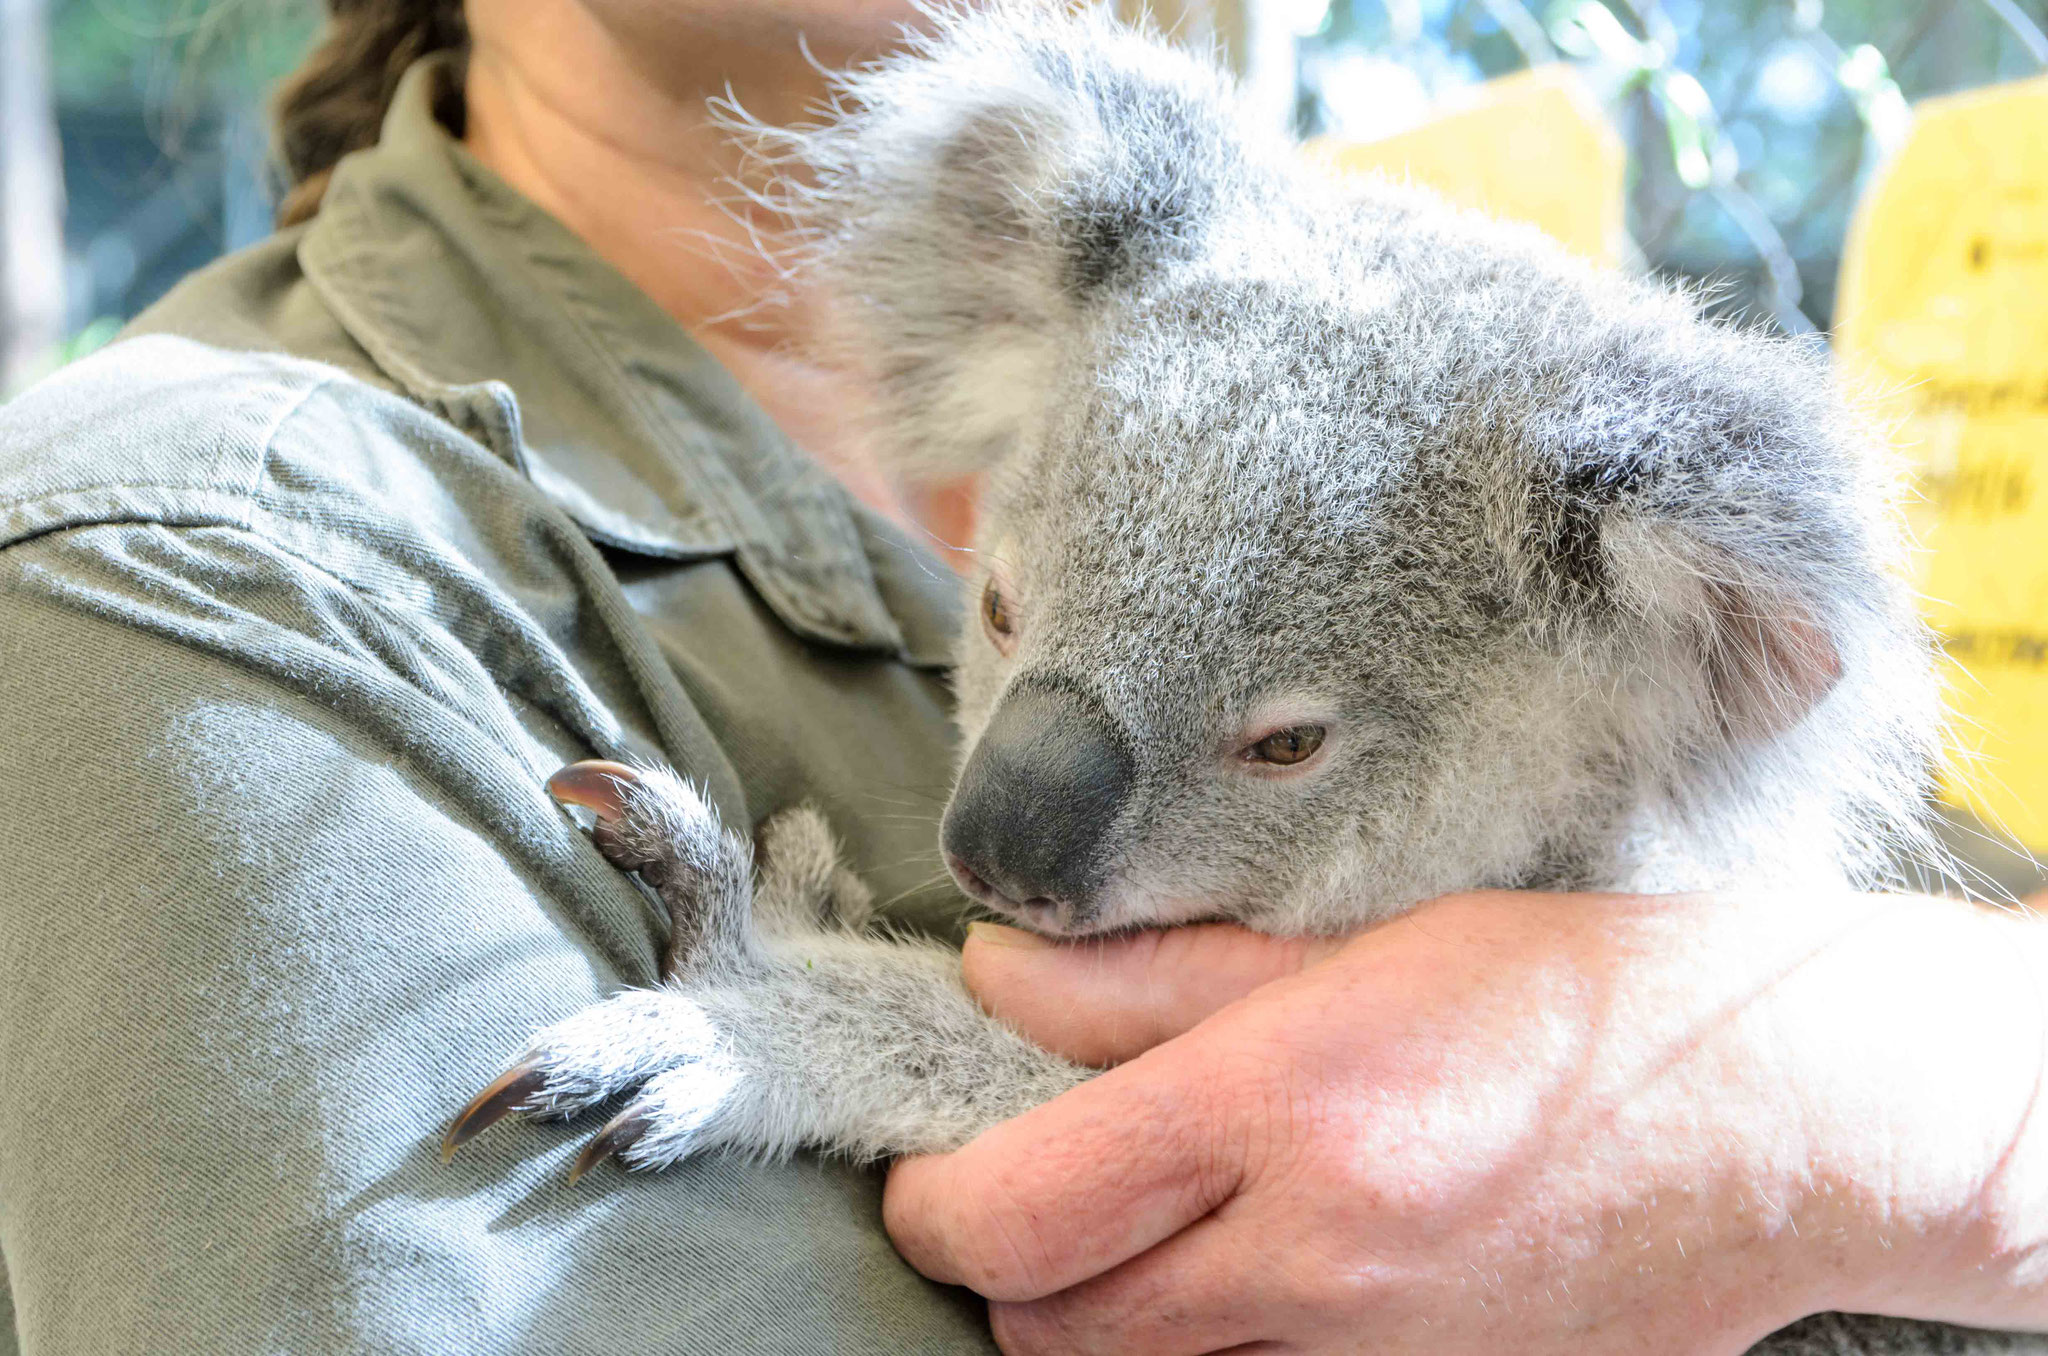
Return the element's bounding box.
[1540,455,1843,741]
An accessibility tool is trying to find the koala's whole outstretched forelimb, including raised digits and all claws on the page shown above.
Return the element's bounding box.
[442,764,1090,1176]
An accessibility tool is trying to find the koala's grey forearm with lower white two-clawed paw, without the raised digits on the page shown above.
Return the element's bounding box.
[460,928,1090,1172]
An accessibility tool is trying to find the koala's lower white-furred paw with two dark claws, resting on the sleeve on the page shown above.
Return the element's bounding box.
[440,987,745,1182]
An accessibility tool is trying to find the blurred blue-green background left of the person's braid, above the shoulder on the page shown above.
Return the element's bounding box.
[0,0,319,389]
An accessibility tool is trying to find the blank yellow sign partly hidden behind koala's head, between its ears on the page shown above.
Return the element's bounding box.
[1309,61,1628,264]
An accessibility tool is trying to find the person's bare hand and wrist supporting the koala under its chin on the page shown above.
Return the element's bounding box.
[885,893,2048,1356]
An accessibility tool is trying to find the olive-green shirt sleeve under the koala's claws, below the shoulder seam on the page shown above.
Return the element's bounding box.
[0,522,987,1356]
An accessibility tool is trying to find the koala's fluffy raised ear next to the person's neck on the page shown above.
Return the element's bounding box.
[768,2,1247,477]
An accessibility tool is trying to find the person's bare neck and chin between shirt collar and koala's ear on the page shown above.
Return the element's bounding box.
[463,0,969,543]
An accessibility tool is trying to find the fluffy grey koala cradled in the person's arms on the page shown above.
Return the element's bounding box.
[446,4,2013,1352]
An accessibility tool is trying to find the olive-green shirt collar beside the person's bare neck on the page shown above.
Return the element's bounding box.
[299,57,944,664]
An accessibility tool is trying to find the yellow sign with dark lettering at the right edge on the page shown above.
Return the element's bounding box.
[1837,78,2048,850]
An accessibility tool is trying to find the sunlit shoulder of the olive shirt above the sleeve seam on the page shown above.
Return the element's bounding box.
[0,334,460,549]
